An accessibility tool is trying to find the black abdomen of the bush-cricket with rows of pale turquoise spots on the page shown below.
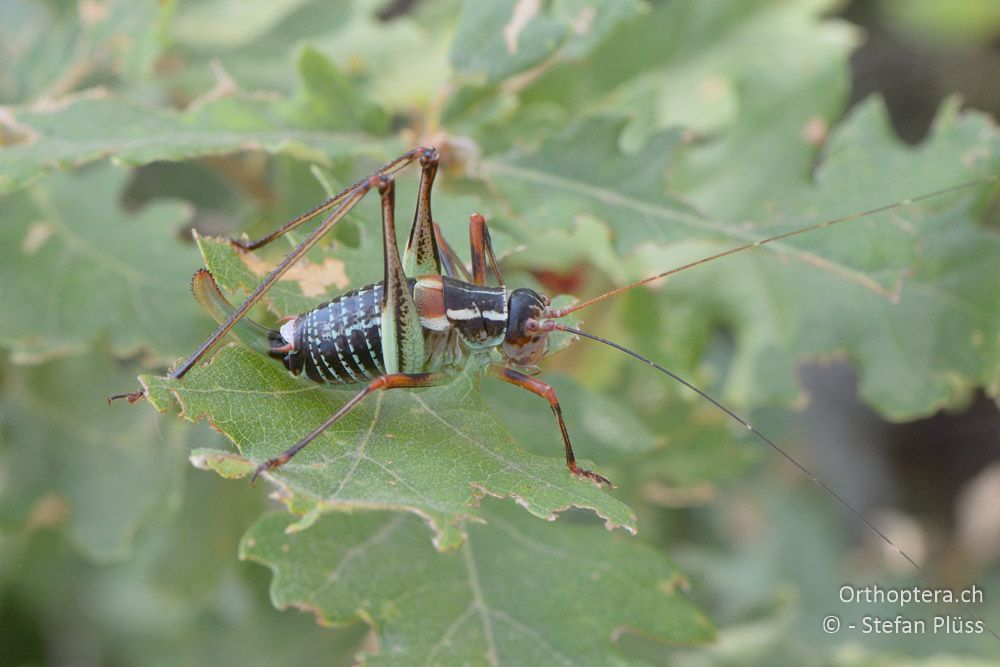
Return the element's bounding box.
[282,283,385,384]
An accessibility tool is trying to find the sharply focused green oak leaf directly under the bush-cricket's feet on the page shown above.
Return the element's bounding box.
[141,347,635,549]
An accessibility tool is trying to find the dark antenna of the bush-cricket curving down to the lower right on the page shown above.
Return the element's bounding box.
[548,320,1000,641]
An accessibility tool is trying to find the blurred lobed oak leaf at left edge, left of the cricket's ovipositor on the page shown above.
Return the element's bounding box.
[0,165,205,366]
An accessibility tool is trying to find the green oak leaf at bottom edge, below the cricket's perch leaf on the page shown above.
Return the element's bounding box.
[240,503,713,665]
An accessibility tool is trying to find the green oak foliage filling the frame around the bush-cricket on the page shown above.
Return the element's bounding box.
[0,0,1000,666]
